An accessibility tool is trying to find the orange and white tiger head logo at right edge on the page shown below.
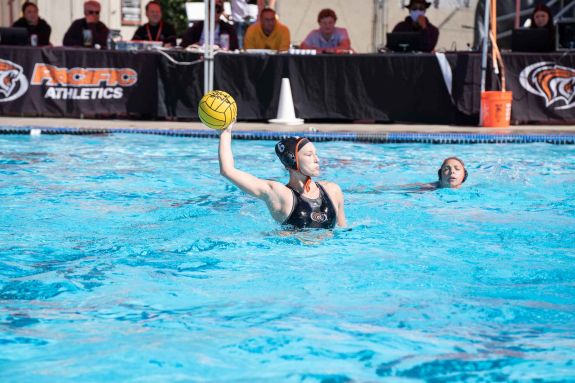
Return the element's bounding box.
[519,62,575,109]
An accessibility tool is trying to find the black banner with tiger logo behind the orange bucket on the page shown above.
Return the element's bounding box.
[449,52,575,124]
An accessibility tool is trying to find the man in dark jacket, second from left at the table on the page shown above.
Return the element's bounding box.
[64,0,110,48]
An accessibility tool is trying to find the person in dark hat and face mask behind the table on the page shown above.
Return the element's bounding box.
[393,0,439,52]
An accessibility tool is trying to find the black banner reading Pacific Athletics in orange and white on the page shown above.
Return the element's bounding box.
[0,47,158,117]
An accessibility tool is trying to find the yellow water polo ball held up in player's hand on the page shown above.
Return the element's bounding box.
[198,90,238,129]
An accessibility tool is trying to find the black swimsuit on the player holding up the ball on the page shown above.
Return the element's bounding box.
[283,182,337,229]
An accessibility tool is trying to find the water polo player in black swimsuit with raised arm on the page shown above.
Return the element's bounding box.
[219,124,346,229]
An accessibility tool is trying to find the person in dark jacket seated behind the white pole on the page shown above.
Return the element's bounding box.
[181,0,239,51]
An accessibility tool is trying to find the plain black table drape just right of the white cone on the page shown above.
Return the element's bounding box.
[289,54,455,124]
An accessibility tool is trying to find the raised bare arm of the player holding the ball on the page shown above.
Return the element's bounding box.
[218,126,273,201]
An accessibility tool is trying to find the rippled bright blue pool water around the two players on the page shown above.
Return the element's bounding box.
[0,135,575,383]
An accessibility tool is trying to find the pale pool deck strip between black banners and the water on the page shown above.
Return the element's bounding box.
[0,116,575,136]
